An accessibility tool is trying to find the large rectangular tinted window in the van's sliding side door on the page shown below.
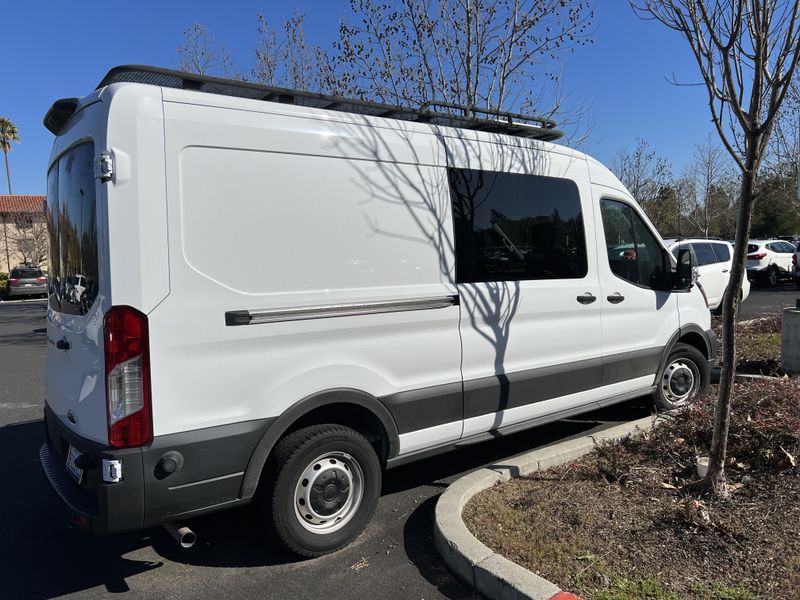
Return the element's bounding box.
[448,169,588,283]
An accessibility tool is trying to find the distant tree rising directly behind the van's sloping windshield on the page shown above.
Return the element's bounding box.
[611,138,678,232]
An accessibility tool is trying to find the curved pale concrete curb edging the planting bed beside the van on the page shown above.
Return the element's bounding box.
[433,417,653,600]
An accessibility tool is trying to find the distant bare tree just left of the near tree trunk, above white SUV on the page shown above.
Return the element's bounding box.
[680,135,736,237]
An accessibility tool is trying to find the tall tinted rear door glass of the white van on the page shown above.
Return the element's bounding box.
[47,142,98,315]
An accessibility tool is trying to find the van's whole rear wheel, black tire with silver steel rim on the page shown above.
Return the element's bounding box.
[256,424,381,558]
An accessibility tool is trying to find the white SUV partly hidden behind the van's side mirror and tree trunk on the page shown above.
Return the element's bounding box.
[665,238,750,312]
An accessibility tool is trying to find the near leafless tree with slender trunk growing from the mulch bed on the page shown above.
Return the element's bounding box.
[630,0,800,496]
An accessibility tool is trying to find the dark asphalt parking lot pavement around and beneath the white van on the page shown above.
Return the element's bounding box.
[0,285,800,600]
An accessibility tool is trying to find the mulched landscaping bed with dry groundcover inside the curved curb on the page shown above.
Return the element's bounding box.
[463,378,800,600]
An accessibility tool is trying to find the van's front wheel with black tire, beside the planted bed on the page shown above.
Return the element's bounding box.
[653,343,711,410]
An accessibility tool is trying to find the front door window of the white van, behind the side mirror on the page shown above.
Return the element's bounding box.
[600,200,665,289]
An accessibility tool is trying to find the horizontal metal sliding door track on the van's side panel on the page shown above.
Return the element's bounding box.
[225,295,458,326]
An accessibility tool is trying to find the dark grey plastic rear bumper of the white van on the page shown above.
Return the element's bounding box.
[39,405,273,534]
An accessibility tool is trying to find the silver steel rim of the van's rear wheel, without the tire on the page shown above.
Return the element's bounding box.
[294,452,364,533]
